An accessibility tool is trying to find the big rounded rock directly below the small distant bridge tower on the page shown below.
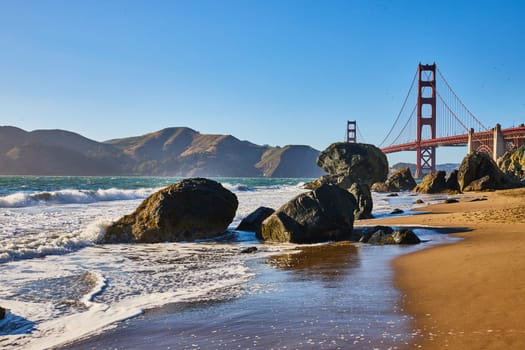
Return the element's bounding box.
[317,142,388,188]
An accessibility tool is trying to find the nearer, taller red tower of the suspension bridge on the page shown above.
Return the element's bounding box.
[415,63,436,178]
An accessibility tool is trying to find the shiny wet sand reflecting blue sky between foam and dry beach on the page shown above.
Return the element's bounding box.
[61,242,430,350]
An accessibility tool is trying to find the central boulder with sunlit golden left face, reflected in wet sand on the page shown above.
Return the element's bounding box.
[259,184,357,243]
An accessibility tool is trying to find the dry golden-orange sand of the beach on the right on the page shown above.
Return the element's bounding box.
[360,188,525,349]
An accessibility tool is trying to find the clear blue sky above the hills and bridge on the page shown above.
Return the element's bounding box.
[0,0,525,162]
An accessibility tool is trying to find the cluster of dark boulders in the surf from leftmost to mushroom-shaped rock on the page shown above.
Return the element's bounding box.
[104,143,422,244]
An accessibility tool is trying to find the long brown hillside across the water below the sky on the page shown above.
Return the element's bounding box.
[0,126,323,177]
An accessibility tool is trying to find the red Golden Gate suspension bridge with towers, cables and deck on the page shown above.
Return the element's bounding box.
[346,63,525,178]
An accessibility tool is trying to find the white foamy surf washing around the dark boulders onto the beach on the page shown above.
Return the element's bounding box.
[0,180,452,349]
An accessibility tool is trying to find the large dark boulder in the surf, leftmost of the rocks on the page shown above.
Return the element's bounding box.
[104,178,238,243]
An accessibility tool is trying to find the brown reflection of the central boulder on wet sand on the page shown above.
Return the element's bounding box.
[266,242,361,282]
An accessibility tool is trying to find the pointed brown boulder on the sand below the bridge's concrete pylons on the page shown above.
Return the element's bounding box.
[458,152,519,191]
